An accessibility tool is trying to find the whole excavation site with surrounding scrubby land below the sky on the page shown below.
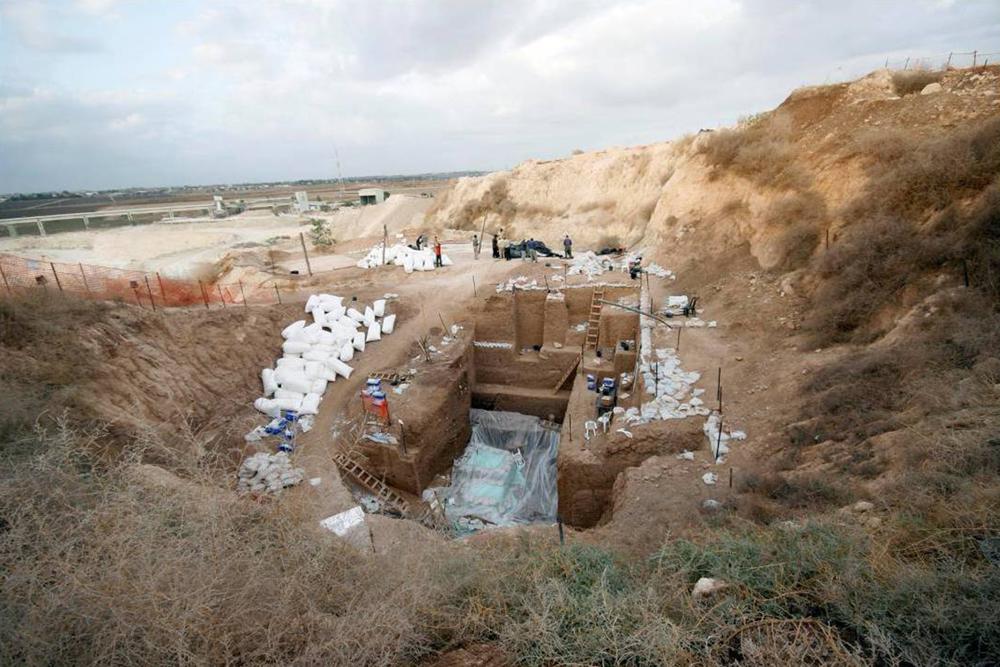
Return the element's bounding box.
[0,41,1000,667]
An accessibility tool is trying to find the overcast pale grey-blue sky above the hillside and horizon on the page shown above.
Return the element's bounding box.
[0,0,1000,192]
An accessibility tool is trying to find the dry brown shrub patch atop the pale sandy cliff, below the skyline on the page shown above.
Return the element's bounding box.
[698,115,812,190]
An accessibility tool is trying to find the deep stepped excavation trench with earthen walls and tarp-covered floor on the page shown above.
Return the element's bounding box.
[344,286,702,528]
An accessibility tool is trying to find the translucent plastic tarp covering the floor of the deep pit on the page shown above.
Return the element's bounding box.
[445,410,559,527]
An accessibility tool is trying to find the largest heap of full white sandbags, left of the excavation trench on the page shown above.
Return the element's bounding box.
[254,294,396,417]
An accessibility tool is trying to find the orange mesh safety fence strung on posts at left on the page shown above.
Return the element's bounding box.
[0,254,301,308]
